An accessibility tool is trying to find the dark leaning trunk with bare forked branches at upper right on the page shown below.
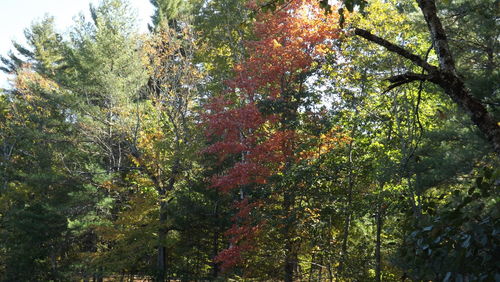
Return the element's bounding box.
[264,0,500,153]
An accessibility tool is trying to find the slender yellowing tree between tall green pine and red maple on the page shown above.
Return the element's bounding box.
[132,1,206,281]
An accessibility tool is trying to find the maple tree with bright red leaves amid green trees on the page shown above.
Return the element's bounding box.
[205,0,340,276]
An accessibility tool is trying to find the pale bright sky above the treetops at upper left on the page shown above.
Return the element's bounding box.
[0,0,153,88]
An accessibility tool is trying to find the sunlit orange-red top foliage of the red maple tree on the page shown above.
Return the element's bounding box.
[229,0,339,98]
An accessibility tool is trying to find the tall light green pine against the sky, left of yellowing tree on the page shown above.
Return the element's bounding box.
[0,0,146,279]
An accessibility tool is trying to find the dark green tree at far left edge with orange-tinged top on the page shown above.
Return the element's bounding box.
[0,59,87,281]
